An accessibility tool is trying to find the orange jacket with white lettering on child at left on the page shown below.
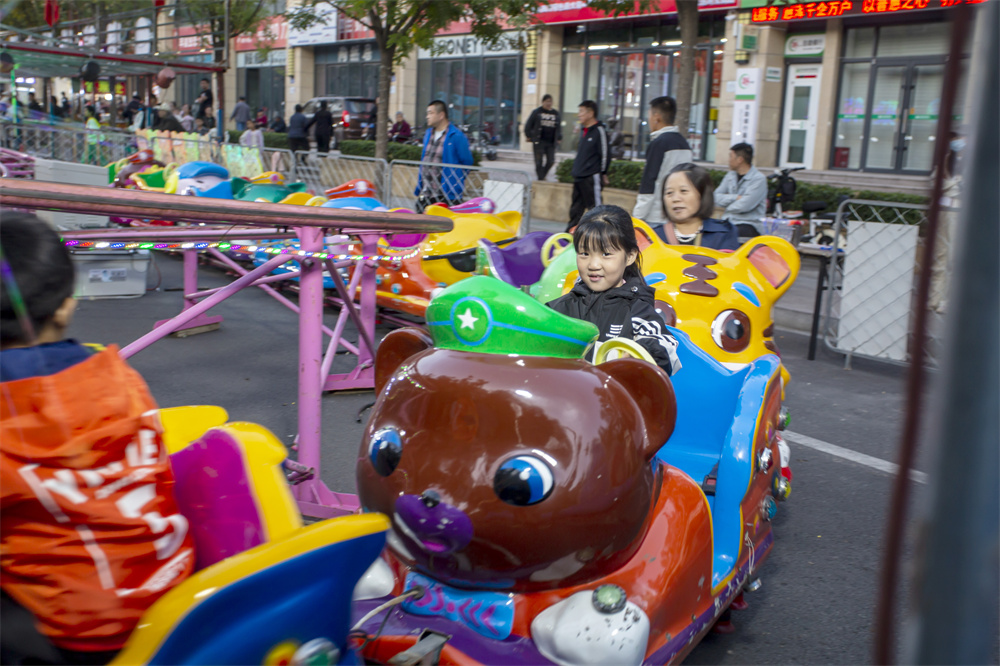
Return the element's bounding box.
[0,347,195,651]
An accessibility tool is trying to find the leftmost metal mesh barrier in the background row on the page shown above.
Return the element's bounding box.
[0,124,137,166]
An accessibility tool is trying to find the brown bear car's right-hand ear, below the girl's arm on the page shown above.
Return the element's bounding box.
[598,358,677,460]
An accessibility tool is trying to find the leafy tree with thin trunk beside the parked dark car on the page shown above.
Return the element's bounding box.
[285,0,556,159]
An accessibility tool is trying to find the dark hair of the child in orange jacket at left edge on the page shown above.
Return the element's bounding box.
[0,209,75,345]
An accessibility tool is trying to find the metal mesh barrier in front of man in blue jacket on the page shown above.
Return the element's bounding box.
[385,160,532,232]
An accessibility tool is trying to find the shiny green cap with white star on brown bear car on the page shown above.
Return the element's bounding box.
[426,275,598,358]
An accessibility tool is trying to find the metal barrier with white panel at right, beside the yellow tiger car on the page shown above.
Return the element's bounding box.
[823,199,944,367]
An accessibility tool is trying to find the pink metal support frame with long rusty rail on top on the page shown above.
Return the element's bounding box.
[0,180,452,518]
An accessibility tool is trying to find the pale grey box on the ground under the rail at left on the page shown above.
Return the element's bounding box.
[71,250,150,299]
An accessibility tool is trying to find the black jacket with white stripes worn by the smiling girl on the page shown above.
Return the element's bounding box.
[548,278,681,375]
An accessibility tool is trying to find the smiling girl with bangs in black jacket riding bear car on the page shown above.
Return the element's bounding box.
[549,206,681,375]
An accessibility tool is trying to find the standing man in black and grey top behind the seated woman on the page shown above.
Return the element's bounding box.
[632,96,692,230]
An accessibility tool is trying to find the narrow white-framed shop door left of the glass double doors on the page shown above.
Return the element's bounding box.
[779,65,821,169]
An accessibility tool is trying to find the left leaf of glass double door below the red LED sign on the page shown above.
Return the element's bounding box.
[865,65,907,170]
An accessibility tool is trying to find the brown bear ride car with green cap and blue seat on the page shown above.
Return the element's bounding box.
[354,276,780,664]
